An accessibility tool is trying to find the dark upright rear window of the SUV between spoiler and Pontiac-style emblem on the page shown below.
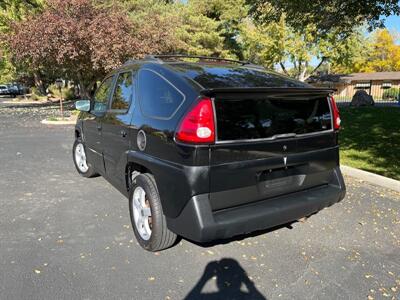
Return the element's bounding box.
[215,97,332,141]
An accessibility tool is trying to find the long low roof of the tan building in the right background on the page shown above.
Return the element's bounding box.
[308,72,400,83]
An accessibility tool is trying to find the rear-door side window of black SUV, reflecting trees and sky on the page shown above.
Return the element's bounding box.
[111,72,134,112]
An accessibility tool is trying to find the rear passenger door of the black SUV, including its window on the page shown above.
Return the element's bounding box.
[102,71,135,183]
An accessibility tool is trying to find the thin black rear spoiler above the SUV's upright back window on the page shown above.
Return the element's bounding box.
[200,87,336,96]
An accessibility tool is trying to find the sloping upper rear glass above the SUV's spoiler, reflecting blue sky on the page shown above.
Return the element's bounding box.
[172,63,310,88]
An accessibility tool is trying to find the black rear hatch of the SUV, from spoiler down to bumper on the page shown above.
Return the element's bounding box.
[203,88,339,210]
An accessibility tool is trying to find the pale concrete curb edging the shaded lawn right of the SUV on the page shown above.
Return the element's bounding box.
[340,165,400,192]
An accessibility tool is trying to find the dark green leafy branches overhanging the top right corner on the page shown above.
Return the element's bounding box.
[248,0,400,34]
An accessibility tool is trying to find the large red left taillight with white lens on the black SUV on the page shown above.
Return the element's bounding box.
[176,97,215,144]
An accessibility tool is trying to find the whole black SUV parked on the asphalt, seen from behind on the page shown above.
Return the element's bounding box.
[73,56,345,251]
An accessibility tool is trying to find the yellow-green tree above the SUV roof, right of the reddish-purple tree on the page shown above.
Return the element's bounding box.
[98,0,230,56]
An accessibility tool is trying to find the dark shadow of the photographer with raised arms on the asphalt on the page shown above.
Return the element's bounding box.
[184,258,267,300]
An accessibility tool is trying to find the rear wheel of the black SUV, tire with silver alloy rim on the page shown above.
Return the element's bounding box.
[129,173,177,252]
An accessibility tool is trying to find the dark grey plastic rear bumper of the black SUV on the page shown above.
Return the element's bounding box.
[167,167,346,242]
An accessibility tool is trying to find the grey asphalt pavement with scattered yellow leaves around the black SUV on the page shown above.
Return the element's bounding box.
[0,101,400,299]
